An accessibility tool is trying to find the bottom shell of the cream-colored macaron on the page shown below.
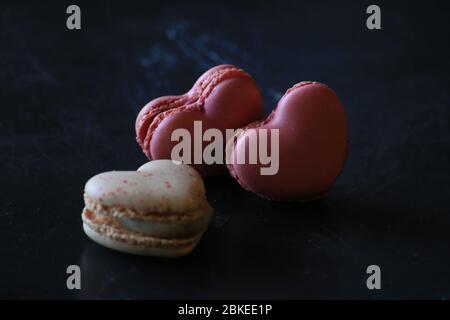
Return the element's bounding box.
[82,210,206,257]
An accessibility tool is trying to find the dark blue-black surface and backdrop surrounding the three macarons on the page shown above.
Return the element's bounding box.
[0,1,450,299]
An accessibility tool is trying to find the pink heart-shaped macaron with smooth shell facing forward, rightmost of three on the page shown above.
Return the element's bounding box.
[227,82,348,201]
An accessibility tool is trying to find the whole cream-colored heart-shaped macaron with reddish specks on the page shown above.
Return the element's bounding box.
[82,160,213,257]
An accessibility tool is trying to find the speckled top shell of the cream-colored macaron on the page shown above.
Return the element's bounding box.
[85,160,207,218]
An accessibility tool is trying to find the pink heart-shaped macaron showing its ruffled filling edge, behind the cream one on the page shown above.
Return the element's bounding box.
[136,65,263,176]
